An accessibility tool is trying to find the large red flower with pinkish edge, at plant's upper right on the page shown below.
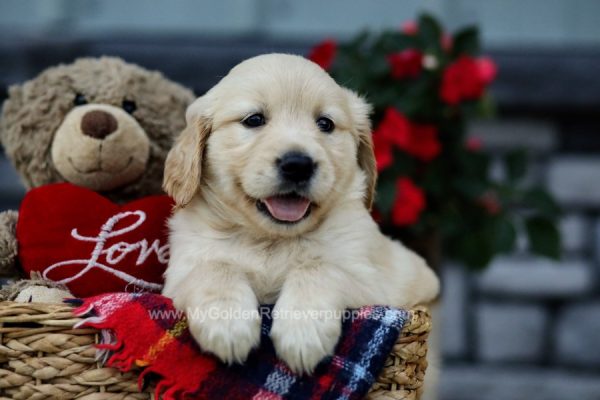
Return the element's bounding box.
[440,55,496,105]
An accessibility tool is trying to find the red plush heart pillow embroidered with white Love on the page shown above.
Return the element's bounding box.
[17,183,173,297]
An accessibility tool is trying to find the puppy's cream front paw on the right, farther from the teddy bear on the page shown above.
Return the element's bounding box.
[271,310,342,374]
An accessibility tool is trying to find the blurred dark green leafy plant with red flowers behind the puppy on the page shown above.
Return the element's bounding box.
[309,15,560,267]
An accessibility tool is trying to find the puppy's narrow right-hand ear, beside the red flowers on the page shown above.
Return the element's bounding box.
[346,89,377,210]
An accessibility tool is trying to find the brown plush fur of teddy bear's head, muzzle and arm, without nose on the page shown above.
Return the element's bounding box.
[0,57,194,276]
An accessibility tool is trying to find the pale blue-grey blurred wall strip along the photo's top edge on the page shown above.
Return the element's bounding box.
[0,0,600,47]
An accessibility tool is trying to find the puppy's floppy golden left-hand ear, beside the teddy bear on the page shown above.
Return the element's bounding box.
[163,99,211,208]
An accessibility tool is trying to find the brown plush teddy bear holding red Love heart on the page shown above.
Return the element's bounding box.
[0,57,194,300]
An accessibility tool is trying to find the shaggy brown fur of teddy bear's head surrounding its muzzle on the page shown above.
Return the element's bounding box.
[0,57,193,202]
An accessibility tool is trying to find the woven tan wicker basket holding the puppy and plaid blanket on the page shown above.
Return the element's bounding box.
[0,302,431,400]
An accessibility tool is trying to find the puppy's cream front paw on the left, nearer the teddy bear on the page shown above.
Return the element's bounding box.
[187,302,261,364]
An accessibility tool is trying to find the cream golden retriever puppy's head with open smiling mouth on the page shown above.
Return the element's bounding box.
[164,54,376,236]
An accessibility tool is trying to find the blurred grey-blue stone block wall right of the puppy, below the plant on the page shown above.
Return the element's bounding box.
[441,119,600,400]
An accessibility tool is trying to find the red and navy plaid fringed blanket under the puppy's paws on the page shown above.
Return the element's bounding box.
[70,293,409,400]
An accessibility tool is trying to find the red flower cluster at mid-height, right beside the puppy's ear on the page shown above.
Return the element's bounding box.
[373,107,441,171]
